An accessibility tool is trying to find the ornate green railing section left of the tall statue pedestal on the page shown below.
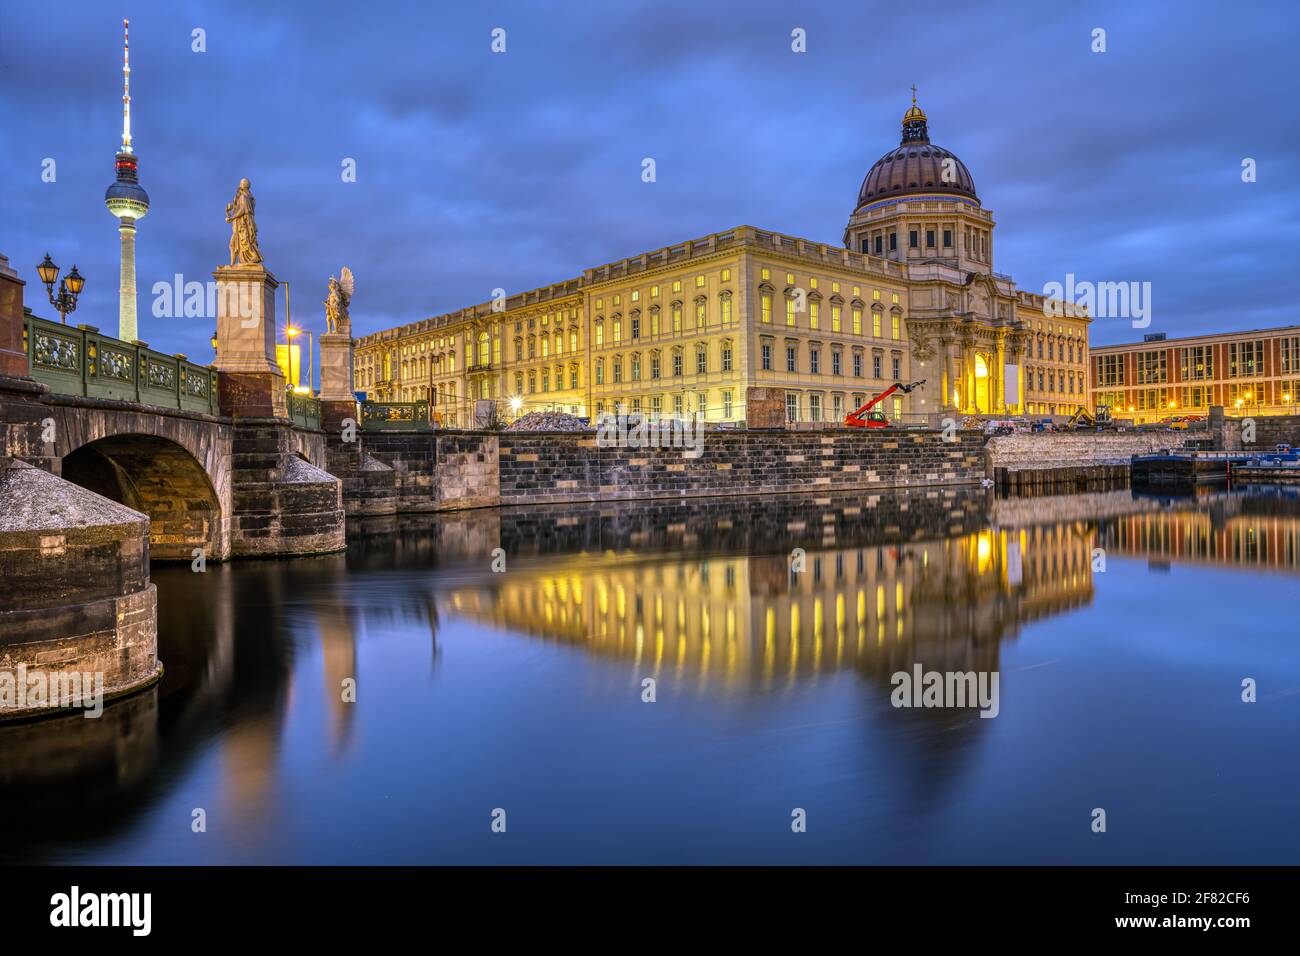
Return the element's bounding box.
[22,315,219,419]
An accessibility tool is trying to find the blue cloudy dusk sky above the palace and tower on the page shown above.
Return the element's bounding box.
[0,0,1300,359]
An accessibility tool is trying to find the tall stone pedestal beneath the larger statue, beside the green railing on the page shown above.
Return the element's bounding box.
[212,265,289,419]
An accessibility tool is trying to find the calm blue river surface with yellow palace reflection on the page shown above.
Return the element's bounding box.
[0,490,1300,864]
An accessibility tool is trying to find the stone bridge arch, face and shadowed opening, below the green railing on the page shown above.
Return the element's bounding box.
[49,402,231,562]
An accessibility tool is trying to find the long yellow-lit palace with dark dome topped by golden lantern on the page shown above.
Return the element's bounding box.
[355,98,1089,425]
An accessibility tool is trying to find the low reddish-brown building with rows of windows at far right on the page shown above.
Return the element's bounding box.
[1092,325,1300,421]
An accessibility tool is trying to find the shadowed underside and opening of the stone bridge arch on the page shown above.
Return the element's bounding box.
[62,434,229,562]
